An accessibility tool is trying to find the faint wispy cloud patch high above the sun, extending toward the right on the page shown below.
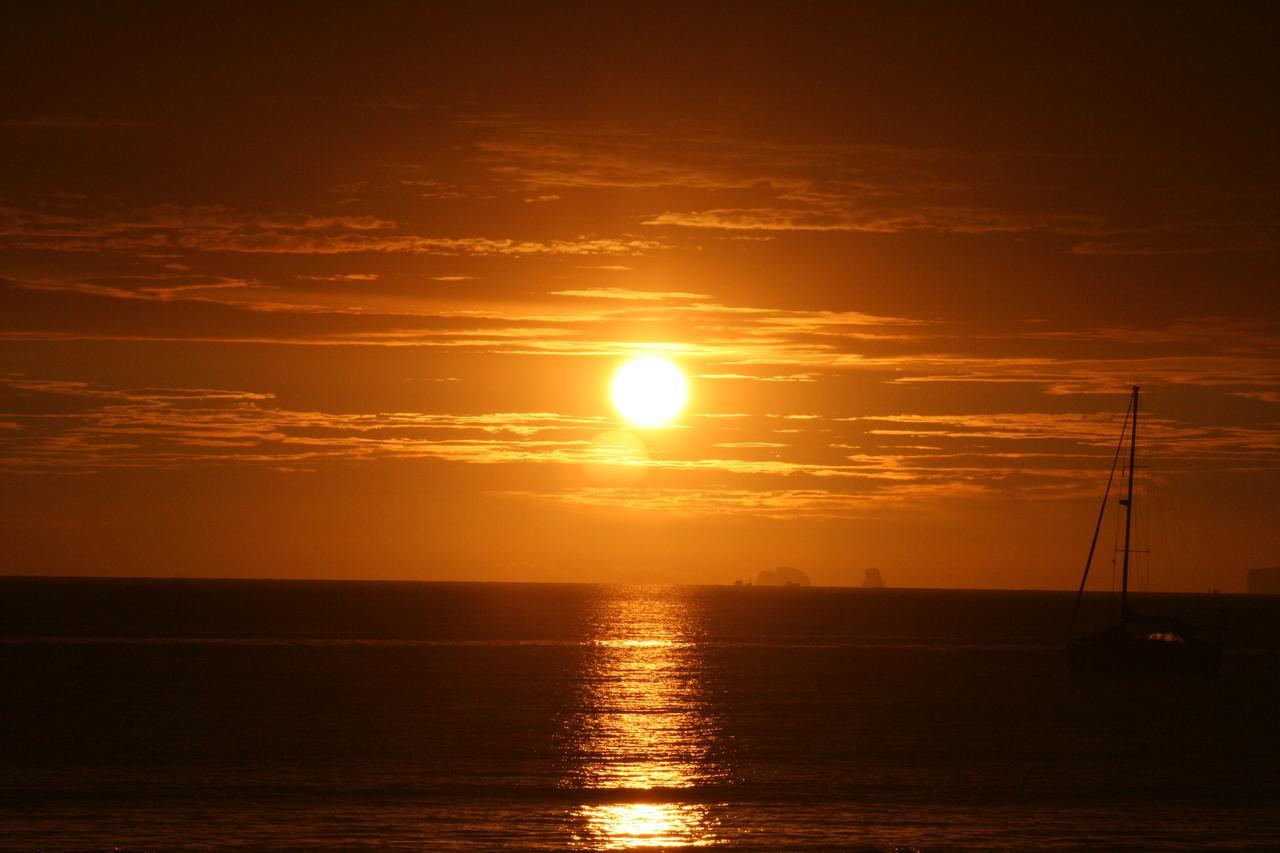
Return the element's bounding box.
[475,123,1107,234]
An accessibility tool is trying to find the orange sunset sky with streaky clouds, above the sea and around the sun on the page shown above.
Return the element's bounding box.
[0,3,1280,590]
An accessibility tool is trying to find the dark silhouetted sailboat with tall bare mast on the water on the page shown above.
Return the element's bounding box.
[1066,386,1222,675]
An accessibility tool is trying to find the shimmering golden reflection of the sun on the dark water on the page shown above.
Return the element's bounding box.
[566,588,727,850]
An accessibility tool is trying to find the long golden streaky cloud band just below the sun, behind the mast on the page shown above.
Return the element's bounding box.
[0,366,1280,517]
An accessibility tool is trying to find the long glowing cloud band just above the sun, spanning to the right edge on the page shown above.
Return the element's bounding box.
[12,273,1280,412]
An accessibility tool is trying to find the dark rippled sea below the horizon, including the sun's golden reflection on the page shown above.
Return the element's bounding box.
[0,579,1280,850]
